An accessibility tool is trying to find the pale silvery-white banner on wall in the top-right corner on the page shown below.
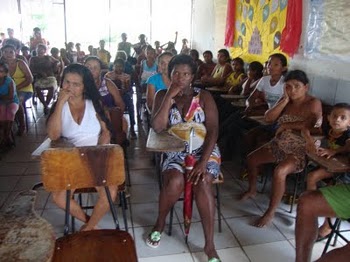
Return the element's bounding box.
[304,0,350,62]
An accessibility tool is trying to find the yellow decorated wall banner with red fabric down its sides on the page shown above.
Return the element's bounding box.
[226,0,302,63]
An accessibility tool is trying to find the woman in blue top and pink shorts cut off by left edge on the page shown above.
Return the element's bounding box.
[0,61,18,148]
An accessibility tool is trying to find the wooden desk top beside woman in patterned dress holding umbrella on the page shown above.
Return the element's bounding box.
[146,128,185,152]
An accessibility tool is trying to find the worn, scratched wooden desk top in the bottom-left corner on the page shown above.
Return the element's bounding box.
[0,190,55,262]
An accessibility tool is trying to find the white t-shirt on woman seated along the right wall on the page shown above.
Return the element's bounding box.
[256,76,284,108]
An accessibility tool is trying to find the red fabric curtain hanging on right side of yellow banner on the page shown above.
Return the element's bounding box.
[278,0,303,56]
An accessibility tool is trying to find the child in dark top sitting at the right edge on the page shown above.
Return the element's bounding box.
[307,103,350,241]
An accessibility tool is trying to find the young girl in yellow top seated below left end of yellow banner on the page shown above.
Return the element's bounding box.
[225,57,247,94]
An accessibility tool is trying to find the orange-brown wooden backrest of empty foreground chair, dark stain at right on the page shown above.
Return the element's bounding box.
[41,145,125,191]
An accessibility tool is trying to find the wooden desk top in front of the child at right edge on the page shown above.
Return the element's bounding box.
[307,153,350,173]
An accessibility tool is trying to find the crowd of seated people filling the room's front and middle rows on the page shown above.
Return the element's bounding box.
[0,27,350,262]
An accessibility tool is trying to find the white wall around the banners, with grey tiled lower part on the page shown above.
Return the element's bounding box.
[192,0,350,104]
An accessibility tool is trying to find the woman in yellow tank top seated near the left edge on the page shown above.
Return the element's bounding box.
[1,45,33,136]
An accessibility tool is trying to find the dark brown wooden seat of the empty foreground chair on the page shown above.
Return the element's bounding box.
[52,229,137,262]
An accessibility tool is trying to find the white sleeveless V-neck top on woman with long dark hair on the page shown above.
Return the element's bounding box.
[62,100,101,146]
